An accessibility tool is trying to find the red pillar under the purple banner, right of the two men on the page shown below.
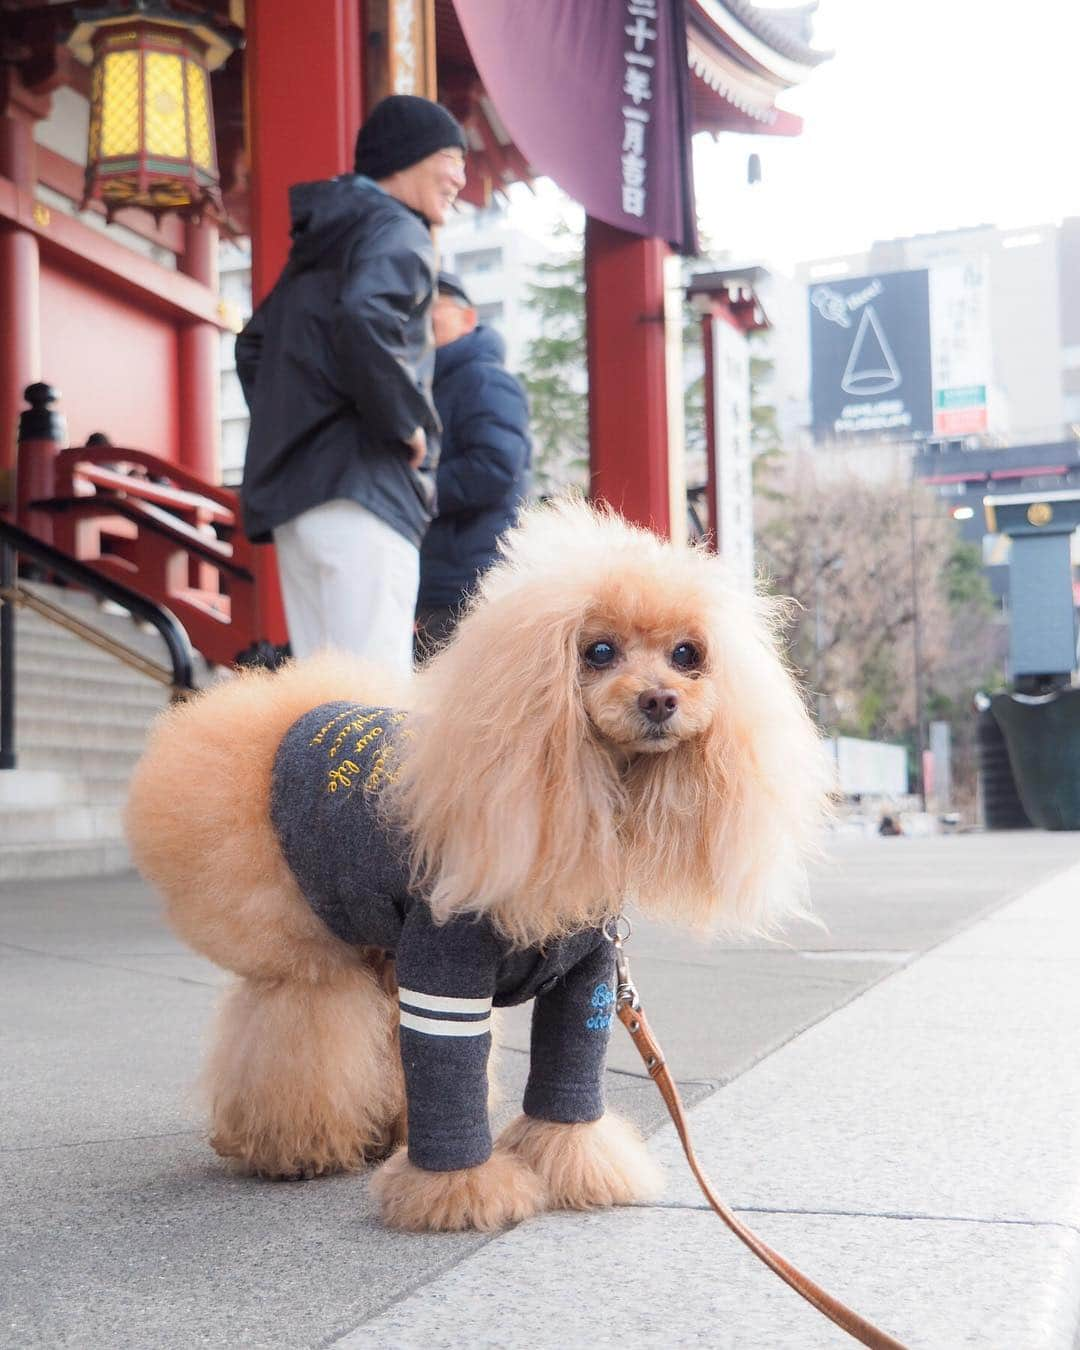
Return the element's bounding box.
[585,216,671,536]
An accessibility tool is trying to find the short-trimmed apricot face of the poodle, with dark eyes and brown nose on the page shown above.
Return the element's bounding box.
[578,582,717,757]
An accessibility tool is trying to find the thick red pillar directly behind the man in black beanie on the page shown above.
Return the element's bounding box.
[244,0,363,304]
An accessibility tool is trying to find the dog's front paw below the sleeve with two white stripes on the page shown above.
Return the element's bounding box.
[371,1149,545,1233]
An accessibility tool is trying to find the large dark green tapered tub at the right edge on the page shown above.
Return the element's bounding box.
[990,689,1080,830]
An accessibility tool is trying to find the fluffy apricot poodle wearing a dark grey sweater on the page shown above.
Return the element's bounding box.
[127,504,828,1230]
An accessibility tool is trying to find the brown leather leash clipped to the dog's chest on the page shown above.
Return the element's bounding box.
[605,918,906,1350]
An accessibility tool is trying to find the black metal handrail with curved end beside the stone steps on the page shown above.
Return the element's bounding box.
[0,520,196,770]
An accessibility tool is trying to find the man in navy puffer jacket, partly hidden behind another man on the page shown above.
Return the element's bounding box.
[416,273,532,660]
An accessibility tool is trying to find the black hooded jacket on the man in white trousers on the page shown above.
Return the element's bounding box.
[236,174,439,544]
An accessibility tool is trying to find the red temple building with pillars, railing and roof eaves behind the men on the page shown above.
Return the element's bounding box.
[0,0,822,659]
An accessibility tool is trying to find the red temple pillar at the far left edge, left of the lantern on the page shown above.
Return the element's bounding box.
[0,80,49,509]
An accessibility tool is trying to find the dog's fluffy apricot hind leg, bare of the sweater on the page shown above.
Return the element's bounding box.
[204,967,404,1179]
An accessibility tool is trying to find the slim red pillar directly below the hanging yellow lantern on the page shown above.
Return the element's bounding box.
[178,221,221,483]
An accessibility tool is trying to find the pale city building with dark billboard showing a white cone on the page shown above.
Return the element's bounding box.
[768,217,1080,623]
